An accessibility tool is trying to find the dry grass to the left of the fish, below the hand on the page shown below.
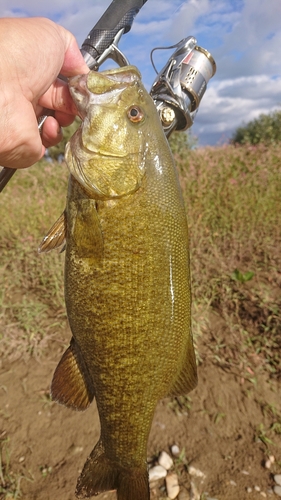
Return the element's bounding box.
[0,163,67,359]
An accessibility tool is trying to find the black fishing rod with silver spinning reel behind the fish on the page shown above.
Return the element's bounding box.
[0,0,216,193]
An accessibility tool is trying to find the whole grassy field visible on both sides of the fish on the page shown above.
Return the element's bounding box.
[0,141,281,378]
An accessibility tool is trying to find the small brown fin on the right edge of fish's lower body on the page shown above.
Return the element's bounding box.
[167,340,197,396]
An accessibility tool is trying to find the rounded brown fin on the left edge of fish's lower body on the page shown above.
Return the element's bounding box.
[51,339,94,411]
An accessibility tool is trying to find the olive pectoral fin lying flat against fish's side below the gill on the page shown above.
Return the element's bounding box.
[73,199,104,264]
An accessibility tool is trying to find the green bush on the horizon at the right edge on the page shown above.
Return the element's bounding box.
[231,111,281,145]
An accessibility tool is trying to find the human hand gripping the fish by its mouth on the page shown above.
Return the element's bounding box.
[0,18,89,168]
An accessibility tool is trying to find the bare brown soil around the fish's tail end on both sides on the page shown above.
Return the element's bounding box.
[0,324,281,500]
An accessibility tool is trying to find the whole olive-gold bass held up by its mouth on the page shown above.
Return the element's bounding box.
[39,66,197,500]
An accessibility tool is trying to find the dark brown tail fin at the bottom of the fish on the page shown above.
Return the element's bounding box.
[76,441,150,500]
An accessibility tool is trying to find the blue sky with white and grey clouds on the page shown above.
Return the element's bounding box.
[0,0,281,146]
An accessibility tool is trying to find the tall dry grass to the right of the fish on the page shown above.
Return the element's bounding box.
[175,146,281,378]
